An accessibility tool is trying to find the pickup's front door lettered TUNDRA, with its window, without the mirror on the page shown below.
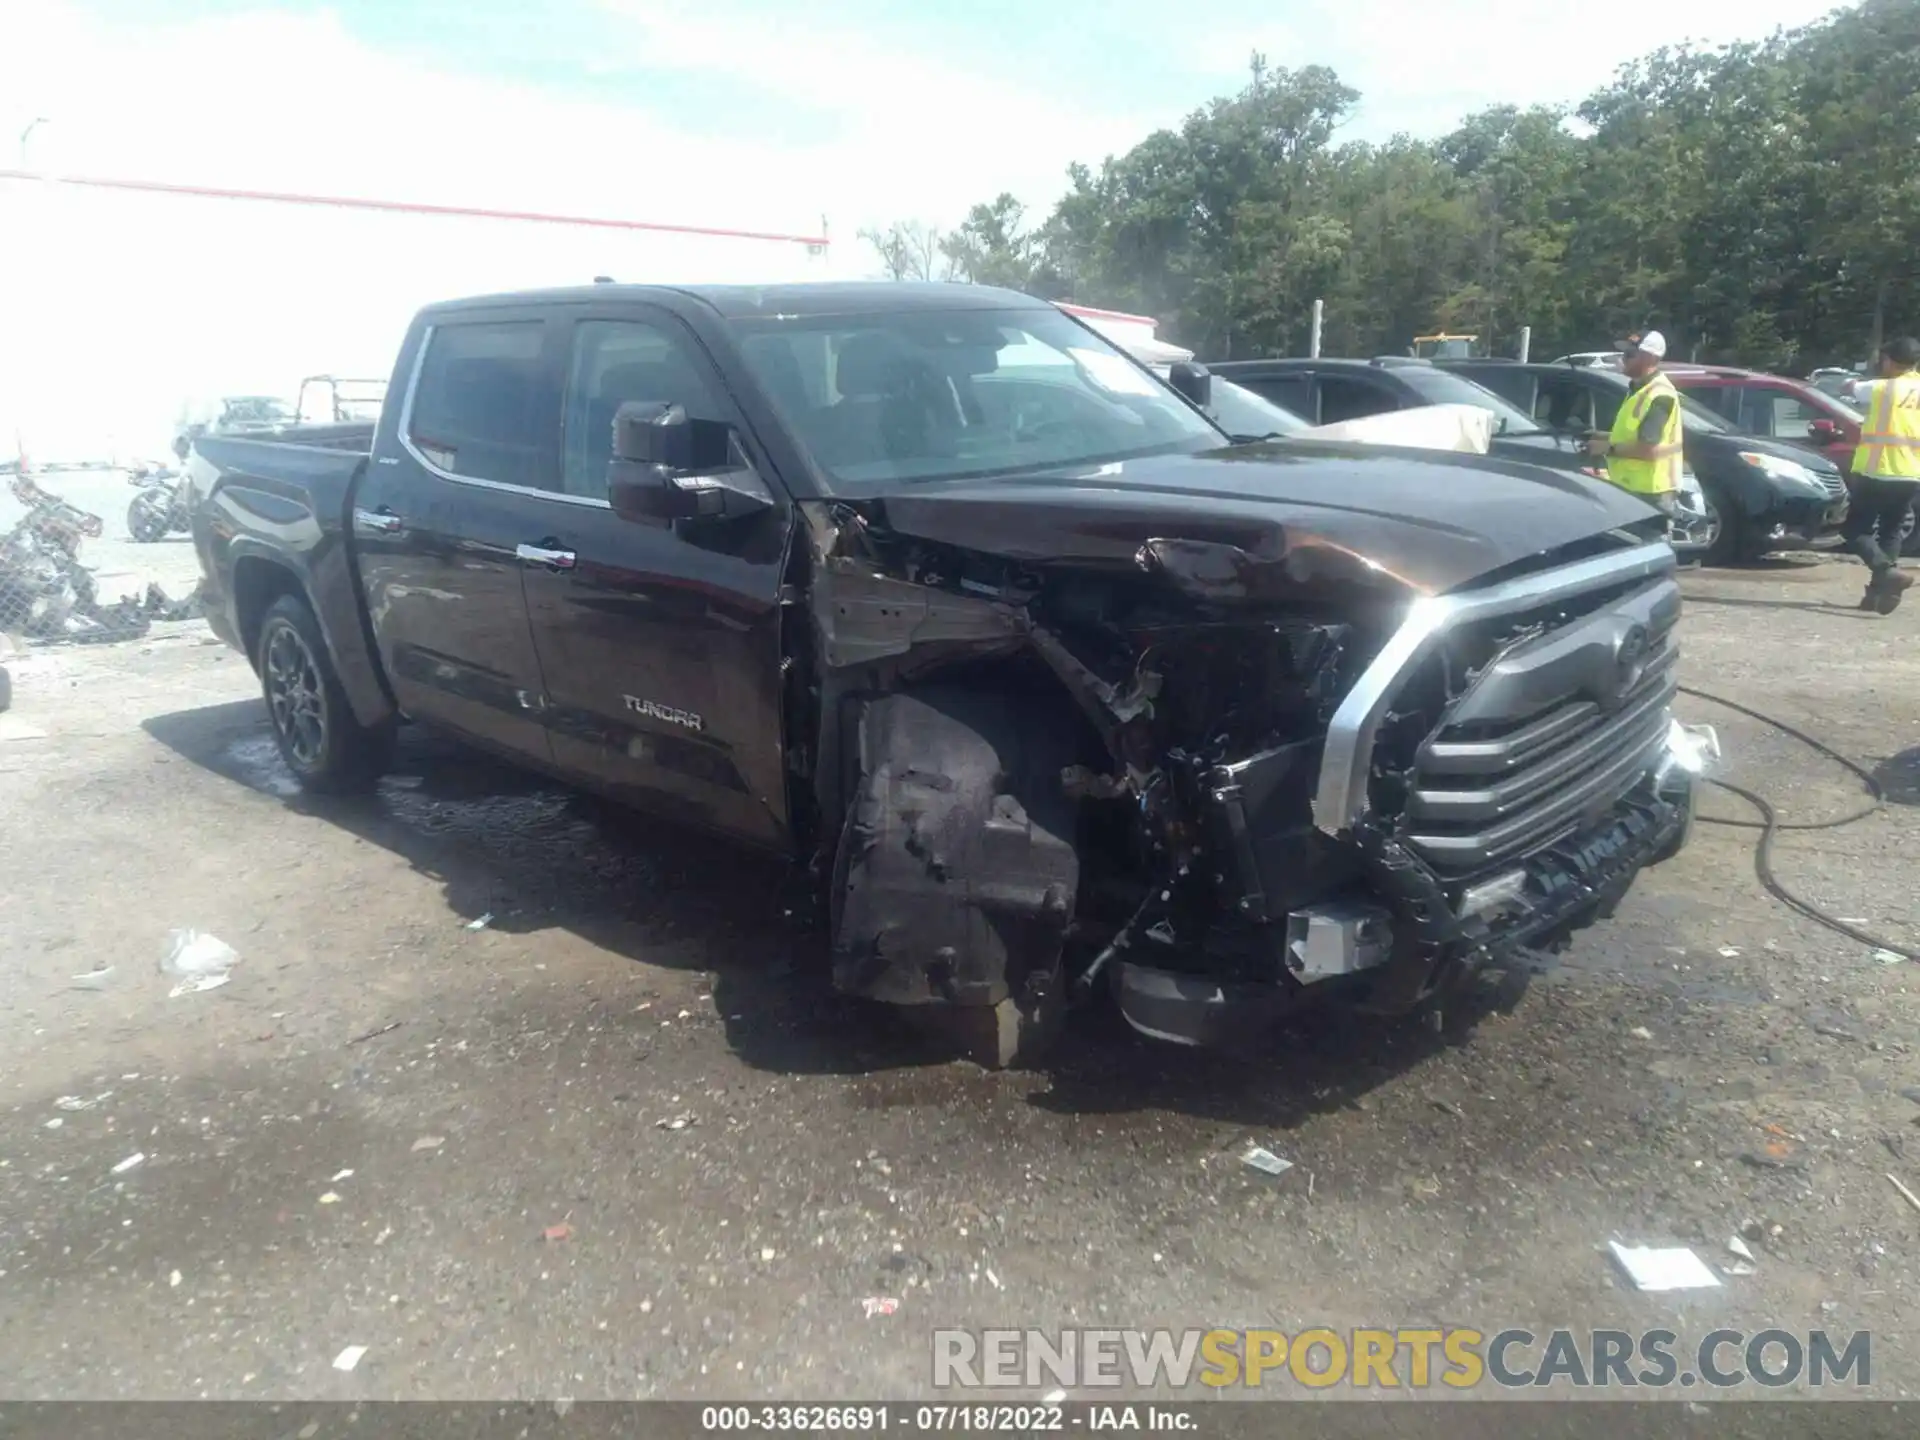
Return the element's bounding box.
[522,303,793,845]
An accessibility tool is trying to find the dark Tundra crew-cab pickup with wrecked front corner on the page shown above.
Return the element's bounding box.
[188,284,1705,1064]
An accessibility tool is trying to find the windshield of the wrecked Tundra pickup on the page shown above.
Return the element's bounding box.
[733,307,1225,492]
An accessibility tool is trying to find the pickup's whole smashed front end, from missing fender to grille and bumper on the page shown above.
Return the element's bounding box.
[791,503,1697,1048]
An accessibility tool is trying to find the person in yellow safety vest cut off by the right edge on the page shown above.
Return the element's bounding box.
[1845,338,1920,614]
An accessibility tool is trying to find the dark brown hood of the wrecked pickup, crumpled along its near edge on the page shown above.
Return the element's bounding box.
[874,440,1655,599]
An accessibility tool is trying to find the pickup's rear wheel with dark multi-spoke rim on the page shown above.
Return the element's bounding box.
[253,595,394,795]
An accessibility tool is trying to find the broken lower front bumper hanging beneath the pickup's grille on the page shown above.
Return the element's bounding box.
[1114,720,1720,1046]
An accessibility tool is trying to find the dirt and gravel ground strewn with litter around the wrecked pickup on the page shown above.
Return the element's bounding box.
[0,506,1920,1434]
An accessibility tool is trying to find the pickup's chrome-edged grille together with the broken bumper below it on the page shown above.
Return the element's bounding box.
[1104,543,1716,1044]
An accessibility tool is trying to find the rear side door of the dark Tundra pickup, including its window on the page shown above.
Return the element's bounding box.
[351,307,559,762]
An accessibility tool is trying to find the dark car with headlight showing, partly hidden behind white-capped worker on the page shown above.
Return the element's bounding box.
[1444,359,1847,564]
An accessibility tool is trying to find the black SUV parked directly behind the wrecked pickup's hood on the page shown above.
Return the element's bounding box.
[1208,355,1720,559]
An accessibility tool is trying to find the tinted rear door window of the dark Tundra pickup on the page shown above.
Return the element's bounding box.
[407,321,551,486]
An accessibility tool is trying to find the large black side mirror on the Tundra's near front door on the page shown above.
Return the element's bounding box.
[607,399,774,524]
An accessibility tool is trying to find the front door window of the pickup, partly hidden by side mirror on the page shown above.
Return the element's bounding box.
[561,321,732,499]
